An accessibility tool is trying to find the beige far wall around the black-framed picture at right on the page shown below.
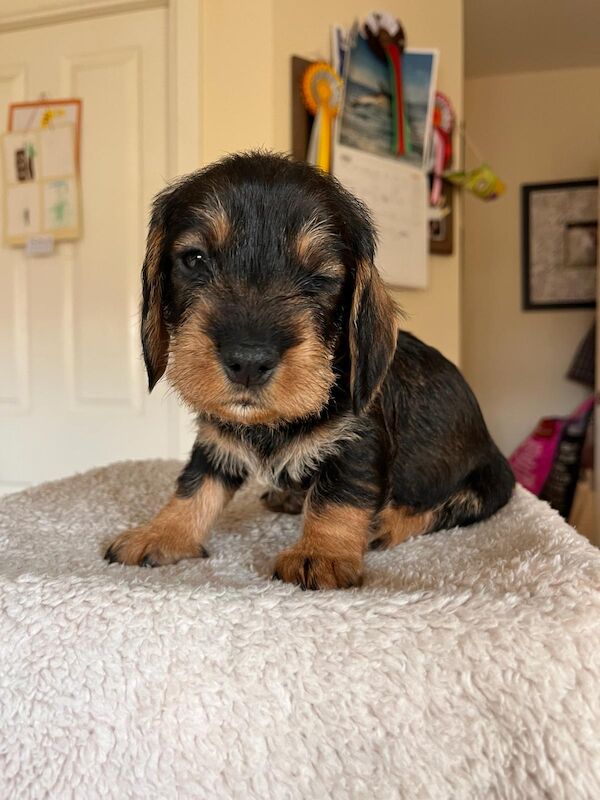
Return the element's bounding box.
[462,68,600,453]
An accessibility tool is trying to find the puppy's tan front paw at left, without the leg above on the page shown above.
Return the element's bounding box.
[104,525,208,567]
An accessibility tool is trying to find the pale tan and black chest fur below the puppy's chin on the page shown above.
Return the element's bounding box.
[198,422,356,488]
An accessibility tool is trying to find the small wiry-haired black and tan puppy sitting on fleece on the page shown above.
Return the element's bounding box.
[106,154,514,589]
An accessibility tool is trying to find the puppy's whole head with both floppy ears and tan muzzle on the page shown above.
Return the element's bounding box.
[142,154,397,424]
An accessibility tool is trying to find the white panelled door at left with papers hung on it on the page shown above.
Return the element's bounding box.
[0,8,177,492]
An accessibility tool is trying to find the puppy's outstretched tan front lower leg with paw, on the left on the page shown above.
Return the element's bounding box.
[105,476,234,567]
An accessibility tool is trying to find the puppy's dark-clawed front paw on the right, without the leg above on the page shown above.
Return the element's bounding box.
[273,548,362,589]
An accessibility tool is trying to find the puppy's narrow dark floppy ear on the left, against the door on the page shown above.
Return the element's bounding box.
[141,200,169,392]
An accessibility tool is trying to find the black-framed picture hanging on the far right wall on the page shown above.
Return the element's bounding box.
[521,179,598,310]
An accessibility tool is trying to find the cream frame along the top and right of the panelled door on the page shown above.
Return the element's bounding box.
[0,0,205,458]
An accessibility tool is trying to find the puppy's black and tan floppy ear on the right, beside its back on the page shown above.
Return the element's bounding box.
[349,259,398,414]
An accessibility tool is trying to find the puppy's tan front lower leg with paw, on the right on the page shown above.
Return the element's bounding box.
[273,502,372,589]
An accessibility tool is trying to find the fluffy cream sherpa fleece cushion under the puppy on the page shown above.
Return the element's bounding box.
[0,461,600,800]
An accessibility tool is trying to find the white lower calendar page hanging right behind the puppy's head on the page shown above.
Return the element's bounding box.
[333,142,429,289]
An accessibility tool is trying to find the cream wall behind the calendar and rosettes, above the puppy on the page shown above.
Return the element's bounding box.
[201,0,463,361]
